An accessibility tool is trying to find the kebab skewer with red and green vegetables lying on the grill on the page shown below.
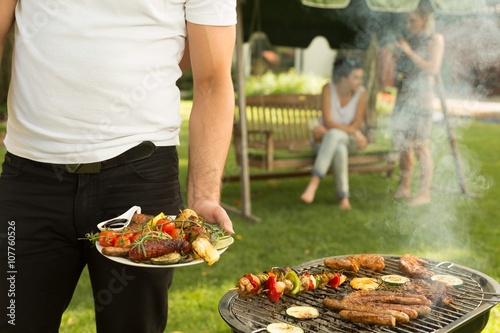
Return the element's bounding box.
[236,267,347,302]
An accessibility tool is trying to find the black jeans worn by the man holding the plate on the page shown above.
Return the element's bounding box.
[0,147,183,333]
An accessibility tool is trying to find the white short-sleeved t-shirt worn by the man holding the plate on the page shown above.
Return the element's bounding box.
[5,0,236,164]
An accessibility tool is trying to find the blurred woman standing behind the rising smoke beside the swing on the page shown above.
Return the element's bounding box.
[392,2,444,206]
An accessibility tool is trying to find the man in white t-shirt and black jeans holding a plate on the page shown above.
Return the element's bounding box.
[0,0,236,333]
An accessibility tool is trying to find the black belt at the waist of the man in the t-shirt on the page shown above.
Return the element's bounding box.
[5,141,156,173]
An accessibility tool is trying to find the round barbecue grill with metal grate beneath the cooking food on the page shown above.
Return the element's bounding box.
[219,255,500,333]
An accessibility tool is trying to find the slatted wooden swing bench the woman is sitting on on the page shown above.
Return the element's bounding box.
[226,94,397,180]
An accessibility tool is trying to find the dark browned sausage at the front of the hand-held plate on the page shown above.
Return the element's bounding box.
[128,239,191,261]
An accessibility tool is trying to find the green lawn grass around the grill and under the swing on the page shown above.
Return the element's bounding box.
[0,104,500,333]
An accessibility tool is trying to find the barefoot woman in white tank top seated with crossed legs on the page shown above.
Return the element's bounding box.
[300,57,368,209]
